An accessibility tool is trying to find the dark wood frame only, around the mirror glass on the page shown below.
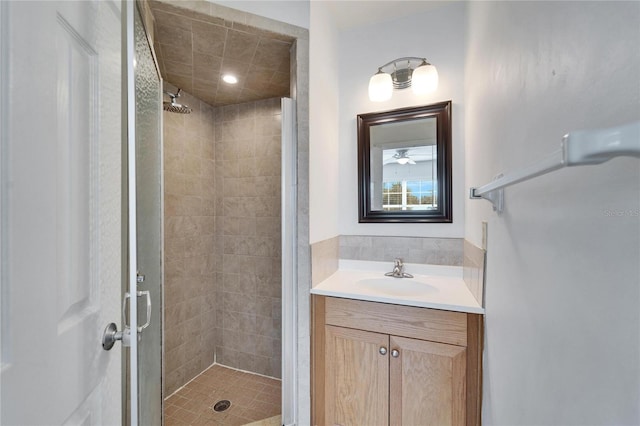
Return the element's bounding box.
[358,101,453,223]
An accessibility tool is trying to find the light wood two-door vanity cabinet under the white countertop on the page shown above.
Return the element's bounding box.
[312,295,482,426]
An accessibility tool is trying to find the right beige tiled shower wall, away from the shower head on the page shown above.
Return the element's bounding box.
[215,99,282,377]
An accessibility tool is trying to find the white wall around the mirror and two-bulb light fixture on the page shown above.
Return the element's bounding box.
[338,2,466,238]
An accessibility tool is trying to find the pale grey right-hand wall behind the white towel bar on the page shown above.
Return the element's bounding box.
[465,2,640,425]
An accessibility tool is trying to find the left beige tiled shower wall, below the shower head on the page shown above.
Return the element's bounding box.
[163,87,218,395]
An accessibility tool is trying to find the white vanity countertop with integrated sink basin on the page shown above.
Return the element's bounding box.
[311,260,484,314]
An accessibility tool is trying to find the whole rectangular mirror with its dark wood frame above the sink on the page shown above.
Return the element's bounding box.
[358,101,453,223]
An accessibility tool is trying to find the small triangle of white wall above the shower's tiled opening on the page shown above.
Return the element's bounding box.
[207,0,309,28]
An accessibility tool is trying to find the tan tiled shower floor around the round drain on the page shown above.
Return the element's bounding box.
[164,365,281,426]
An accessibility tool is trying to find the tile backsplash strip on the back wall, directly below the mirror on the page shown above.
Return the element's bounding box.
[340,235,463,266]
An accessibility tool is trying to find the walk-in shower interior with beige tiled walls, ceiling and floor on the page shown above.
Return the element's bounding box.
[150,1,297,425]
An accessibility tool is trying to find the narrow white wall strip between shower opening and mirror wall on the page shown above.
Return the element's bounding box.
[309,1,342,244]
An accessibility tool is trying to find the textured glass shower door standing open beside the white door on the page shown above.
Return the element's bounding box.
[134,2,163,425]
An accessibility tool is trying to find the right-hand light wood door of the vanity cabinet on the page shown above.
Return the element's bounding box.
[389,336,466,426]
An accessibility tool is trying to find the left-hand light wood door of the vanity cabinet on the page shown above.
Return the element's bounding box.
[325,326,389,426]
